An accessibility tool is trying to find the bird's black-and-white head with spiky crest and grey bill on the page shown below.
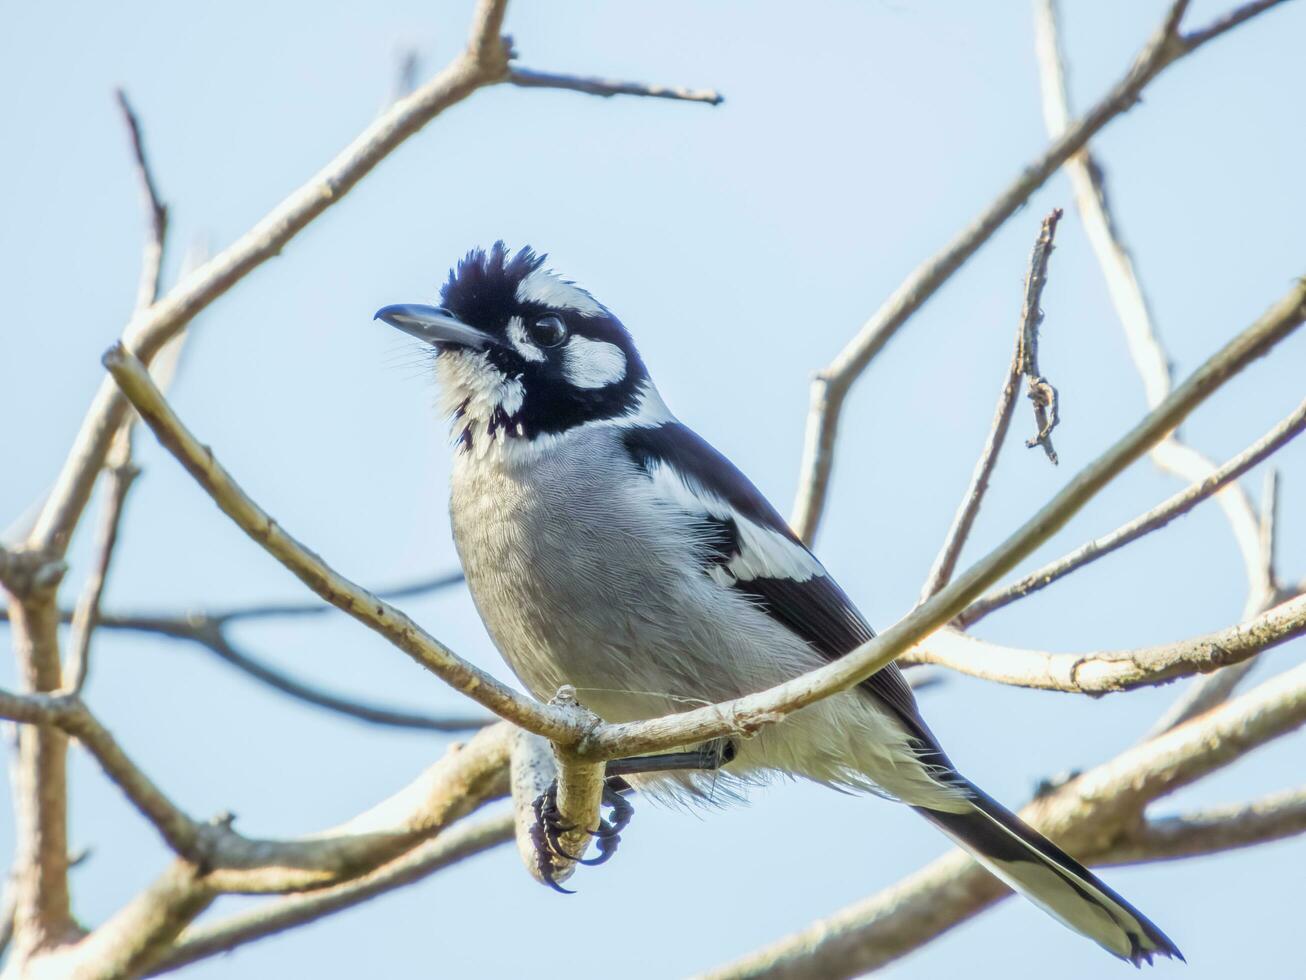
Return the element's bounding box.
[376,242,649,444]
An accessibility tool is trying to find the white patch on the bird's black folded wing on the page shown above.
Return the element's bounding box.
[650,463,825,587]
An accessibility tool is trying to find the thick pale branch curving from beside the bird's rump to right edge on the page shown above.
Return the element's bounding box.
[904,596,1306,695]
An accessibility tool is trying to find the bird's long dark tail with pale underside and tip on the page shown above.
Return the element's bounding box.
[913,784,1183,966]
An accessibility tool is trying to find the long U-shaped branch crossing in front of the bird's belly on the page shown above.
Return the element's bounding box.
[104,270,1306,760]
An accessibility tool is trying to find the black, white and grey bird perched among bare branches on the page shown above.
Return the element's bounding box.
[376,242,1182,964]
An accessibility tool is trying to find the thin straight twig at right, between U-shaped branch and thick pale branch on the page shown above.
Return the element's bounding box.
[956,401,1306,627]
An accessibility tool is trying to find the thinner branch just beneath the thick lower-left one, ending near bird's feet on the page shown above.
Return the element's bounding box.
[149,814,512,976]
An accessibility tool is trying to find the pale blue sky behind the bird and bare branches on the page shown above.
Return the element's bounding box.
[0,0,1306,980]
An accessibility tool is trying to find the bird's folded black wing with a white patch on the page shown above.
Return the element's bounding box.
[624,422,952,768]
